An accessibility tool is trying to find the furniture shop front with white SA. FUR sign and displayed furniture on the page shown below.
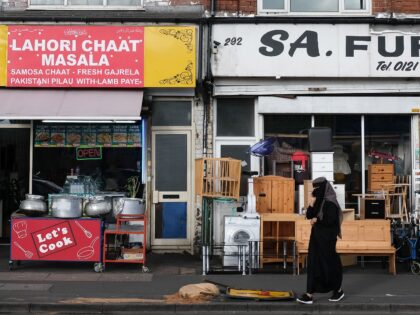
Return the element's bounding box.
[203,19,420,272]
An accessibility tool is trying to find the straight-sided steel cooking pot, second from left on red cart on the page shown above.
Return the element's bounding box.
[51,195,83,218]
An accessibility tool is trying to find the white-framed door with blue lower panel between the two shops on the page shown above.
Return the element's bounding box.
[151,130,192,247]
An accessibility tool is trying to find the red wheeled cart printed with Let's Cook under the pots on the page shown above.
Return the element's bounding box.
[9,214,102,272]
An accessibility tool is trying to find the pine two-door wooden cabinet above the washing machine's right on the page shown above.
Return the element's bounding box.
[254,176,295,213]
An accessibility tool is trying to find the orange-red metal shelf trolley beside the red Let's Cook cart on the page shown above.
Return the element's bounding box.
[102,215,148,272]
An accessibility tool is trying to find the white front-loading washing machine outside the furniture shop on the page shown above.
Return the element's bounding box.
[223,214,260,267]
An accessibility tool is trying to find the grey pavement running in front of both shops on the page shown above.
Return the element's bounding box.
[0,246,420,315]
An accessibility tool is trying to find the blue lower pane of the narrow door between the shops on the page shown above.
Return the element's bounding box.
[155,202,187,239]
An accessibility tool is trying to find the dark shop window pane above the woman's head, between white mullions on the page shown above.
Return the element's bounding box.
[315,115,362,209]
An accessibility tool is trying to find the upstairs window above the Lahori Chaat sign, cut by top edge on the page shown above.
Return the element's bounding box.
[29,0,143,9]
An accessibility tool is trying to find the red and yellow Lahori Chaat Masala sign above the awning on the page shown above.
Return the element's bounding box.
[0,25,196,88]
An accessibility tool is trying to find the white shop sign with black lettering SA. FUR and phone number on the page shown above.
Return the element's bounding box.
[212,24,420,78]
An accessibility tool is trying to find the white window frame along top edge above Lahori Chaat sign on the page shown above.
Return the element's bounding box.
[28,0,144,11]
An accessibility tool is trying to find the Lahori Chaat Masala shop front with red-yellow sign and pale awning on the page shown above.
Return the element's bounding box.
[0,25,196,262]
